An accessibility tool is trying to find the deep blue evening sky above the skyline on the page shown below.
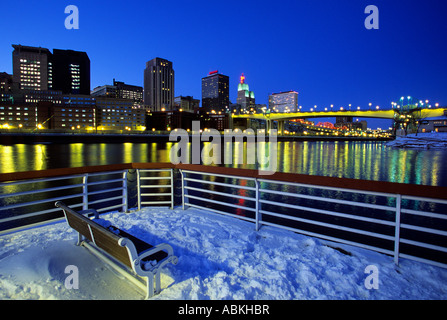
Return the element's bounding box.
[0,0,447,129]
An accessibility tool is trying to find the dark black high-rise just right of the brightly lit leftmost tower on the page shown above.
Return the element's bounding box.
[49,49,90,95]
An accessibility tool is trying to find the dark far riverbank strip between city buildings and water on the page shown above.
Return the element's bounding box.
[0,132,390,145]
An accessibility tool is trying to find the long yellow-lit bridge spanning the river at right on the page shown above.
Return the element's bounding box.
[232,107,447,131]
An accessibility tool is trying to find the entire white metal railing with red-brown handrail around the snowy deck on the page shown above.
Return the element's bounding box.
[0,163,447,267]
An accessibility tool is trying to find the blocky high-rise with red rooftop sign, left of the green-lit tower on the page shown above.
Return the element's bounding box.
[202,70,230,113]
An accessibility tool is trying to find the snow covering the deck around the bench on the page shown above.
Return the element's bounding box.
[0,208,447,300]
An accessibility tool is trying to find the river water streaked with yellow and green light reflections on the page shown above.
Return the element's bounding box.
[0,141,447,186]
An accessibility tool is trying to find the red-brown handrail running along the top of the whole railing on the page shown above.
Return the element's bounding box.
[0,162,447,200]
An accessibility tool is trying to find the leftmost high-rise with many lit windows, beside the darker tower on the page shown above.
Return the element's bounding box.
[12,44,52,90]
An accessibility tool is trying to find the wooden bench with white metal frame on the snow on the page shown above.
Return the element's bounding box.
[55,201,178,298]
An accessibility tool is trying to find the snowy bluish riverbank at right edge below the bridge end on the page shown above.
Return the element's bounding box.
[386,132,447,149]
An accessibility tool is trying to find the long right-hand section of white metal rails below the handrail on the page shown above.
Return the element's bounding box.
[181,166,447,268]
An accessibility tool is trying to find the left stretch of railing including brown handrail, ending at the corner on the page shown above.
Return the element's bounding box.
[0,163,174,234]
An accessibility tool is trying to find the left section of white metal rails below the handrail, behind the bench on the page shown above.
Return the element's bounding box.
[0,170,128,231]
